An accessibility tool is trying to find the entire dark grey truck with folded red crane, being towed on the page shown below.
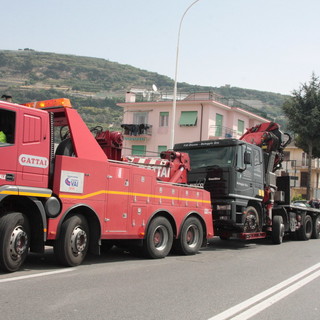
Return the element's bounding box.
[174,122,320,244]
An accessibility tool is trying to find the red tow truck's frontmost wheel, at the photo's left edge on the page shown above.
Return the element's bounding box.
[0,212,30,272]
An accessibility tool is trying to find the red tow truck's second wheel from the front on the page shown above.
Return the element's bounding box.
[54,215,89,267]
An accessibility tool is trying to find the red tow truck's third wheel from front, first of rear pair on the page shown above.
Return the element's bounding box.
[143,217,173,259]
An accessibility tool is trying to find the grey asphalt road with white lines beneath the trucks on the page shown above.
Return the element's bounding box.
[0,239,320,320]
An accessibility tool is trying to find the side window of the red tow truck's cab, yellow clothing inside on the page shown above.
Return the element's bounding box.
[0,109,16,147]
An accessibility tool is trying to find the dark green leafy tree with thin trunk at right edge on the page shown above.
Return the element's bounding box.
[283,73,320,199]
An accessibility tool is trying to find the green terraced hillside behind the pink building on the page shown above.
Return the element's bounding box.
[0,49,287,130]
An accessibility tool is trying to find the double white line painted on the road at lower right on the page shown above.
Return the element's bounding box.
[208,263,320,320]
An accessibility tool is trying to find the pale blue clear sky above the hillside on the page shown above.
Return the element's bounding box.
[0,0,320,94]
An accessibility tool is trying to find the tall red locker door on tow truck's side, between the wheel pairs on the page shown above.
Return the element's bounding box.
[105,162,129,233]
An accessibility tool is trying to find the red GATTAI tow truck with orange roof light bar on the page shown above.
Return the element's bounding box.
[0,99,213,272]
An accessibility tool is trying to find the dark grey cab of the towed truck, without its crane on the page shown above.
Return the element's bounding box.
[174,139,268,236]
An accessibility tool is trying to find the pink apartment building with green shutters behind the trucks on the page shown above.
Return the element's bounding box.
[118,92,268,157]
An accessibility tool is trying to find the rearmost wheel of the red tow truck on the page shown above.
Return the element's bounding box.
[173,217,203,255]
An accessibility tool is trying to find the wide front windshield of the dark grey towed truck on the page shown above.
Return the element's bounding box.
[181,146,236,169]
